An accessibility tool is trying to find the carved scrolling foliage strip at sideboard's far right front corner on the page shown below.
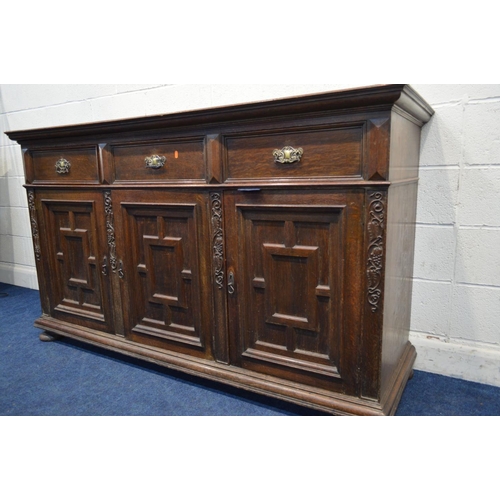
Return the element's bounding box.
[367,192,385,313]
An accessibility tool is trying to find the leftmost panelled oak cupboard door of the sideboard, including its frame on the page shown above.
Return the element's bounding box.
[35,190,113,332]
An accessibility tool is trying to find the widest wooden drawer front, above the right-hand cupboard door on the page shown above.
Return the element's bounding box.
[225,125,364,181]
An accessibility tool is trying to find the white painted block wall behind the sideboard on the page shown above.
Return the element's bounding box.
[0,83,500,386]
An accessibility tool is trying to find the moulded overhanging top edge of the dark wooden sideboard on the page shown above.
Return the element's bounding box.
[5,84,434,143]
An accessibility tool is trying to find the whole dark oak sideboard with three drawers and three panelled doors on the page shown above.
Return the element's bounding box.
[4,84,433,415]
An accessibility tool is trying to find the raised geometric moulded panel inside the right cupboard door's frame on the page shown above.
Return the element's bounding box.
[232,204,344,378]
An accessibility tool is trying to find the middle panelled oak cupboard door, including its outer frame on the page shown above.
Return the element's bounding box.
[113,190,212,359]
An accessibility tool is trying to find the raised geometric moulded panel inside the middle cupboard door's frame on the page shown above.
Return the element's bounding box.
[122,203,202,347]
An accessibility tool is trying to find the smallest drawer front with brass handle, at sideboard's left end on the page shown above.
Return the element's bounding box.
[31,147,99,184]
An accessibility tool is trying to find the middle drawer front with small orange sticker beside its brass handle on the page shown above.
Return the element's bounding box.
[113,137,206,182]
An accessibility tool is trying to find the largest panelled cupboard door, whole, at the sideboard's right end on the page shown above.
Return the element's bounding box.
[225,191,363,394]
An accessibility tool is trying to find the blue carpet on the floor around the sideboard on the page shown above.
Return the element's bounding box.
[0,283,500,416]
